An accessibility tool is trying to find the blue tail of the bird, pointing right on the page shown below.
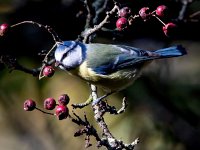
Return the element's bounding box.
[154,45,187,58]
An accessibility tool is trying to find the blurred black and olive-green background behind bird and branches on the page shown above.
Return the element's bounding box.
[0,0,200,150]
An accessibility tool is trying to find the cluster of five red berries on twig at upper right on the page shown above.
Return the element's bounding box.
[116,5,176,36]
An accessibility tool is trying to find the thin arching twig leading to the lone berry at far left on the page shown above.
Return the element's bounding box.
[11,21,62,42]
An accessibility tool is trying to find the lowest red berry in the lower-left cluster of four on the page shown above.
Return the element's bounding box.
[56,105,69,120]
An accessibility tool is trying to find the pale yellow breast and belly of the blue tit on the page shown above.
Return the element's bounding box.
[70,62,141,92]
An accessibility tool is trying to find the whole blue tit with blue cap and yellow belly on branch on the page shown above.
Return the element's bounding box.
[54,41,186,102]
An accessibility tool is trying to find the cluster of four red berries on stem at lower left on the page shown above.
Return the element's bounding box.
[24,94,70,120]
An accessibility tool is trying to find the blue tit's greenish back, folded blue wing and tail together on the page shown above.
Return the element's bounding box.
[87,44,186,75]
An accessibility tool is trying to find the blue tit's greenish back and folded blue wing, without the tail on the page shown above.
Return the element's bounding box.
[87,44,157,75]
